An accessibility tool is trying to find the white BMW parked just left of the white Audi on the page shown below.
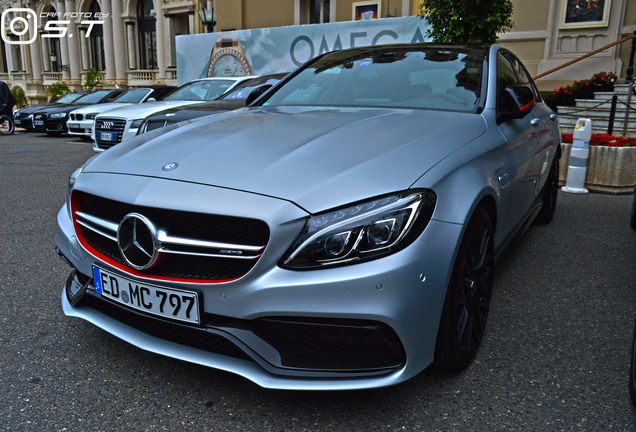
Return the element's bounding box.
[66,86,176,141]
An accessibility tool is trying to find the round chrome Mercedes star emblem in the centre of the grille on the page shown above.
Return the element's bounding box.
[117,213,159,270]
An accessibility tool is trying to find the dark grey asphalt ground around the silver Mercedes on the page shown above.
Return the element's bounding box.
[0,133,636,431]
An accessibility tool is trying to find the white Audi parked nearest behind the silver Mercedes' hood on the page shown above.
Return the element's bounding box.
[92,76,254,152]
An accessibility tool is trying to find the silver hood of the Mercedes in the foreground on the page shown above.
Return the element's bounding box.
[85,107,486,213]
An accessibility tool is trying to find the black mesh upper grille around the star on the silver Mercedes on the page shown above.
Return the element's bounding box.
[75,191,269,281]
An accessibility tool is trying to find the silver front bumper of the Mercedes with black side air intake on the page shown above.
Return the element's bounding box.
[56,174,462,390]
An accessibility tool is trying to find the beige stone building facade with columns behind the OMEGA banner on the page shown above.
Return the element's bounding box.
[0,0,636,103]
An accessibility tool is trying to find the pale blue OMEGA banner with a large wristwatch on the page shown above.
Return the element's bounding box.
[176,16,428,85]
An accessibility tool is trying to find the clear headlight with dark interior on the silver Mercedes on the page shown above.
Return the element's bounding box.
[281,190,437,269]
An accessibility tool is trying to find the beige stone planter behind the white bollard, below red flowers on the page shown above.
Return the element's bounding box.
[559,144,636,194]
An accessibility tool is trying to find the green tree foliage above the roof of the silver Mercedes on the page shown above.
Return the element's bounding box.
[420,0,514,45]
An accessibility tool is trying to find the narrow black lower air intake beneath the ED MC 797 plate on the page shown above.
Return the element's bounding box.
[81,295,249,360]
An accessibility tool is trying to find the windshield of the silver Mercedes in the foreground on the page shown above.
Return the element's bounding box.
[263,47,485,112]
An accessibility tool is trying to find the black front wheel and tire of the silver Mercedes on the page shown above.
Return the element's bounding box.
[433,207,494,372]
